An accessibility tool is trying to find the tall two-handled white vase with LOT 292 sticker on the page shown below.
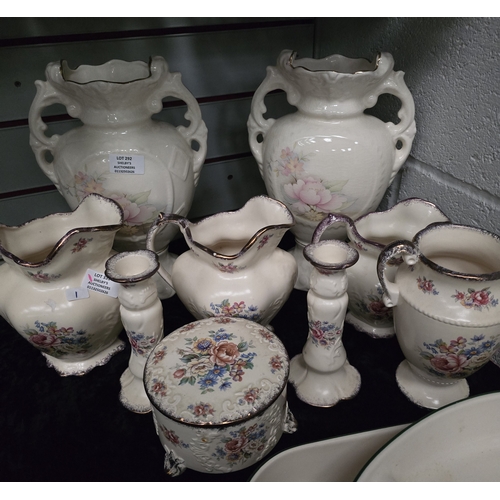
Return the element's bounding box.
[29,57,207,294]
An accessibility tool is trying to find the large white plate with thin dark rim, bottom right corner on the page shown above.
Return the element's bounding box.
[357,392,500,482]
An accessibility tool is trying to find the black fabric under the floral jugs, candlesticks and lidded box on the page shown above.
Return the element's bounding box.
[0,235,500,482]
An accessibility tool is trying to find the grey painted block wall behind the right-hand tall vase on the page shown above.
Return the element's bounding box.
[316,17,500,234]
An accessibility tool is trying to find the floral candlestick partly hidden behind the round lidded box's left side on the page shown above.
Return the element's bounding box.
[105,250,163,413]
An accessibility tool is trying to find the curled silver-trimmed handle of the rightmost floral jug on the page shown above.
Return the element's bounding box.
[377,240,418,307]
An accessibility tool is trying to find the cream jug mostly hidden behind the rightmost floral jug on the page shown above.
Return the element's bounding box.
[312,198,448,338]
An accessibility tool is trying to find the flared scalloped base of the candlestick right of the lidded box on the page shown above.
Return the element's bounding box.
[290,355,361,408]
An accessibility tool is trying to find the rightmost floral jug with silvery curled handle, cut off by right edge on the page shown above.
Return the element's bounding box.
[378,222,500,409]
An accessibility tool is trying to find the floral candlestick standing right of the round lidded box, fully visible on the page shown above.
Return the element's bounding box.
[290,237,361,407]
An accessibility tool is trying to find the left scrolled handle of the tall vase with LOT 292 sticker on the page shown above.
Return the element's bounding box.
[28,80,65,189]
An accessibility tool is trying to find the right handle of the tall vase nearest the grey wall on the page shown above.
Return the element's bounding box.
[376,71,417,183]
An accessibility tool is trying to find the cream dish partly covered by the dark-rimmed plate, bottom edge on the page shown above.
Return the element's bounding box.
[250,424,408,482]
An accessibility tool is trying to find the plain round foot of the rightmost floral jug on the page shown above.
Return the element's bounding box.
[396,360,469,410]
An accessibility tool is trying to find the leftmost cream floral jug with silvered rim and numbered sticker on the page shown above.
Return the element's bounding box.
[0,194,125,376]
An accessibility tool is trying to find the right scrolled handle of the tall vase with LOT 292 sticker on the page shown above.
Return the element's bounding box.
[151,57,208,187]
